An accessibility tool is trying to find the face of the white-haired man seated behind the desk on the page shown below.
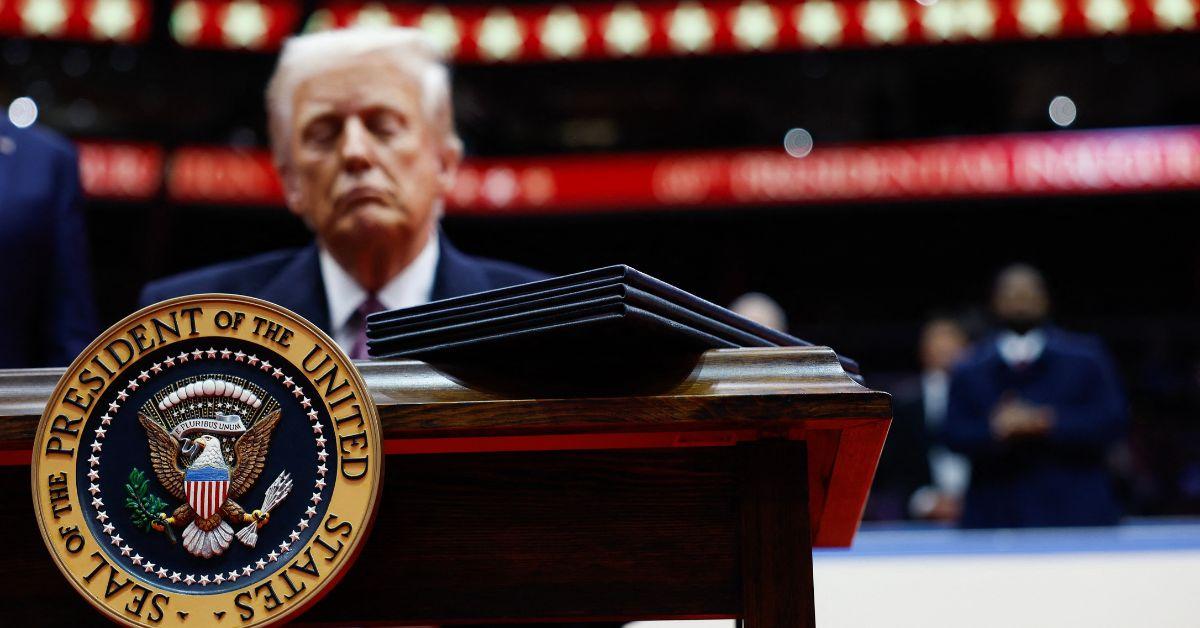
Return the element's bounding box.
[283,55,458,253]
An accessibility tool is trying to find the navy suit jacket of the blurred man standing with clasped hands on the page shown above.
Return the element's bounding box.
[944,329,1128,527]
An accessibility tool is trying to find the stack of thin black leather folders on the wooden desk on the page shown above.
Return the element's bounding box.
[367,265,858,393]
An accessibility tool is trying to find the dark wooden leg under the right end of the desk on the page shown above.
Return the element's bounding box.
[738,441,816,628]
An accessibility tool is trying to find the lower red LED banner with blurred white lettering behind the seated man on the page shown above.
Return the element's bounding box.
[80,127,1200,210]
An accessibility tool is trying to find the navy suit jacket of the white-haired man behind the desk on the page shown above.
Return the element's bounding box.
[140,235,546,333]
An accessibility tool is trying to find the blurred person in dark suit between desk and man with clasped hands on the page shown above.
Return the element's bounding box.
[870,316,971,521]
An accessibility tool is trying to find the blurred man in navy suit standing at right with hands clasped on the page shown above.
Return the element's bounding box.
[944,264,1128,527]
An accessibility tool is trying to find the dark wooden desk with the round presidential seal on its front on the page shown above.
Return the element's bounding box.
[0,347,890,628]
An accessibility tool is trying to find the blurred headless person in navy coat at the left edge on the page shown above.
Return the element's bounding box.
[0,115,97,369]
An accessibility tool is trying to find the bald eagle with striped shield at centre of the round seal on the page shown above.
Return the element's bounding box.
[138,376,292,558]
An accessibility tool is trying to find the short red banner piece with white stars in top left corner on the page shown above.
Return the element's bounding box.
[0,0,150,42]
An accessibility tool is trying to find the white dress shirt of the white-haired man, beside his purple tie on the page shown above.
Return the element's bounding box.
[319,233,439,353]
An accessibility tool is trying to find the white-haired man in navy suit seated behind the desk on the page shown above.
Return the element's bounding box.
[142,29,544,359]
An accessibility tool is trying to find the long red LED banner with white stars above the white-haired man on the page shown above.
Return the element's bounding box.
[162,0,1200,62]
